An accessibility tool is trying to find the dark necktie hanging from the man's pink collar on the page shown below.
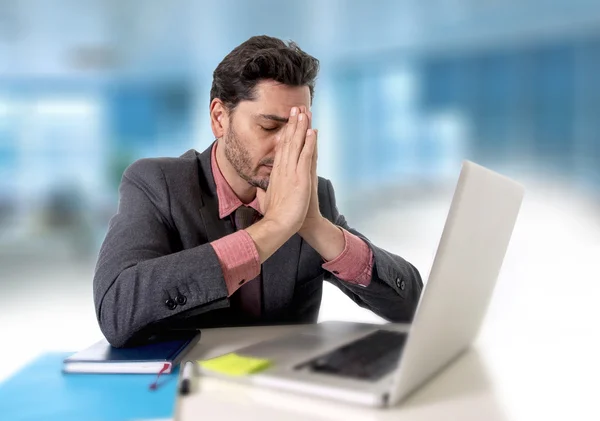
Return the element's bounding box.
[231,206,262,319]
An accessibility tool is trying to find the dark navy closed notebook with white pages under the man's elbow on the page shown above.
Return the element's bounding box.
[63,331,200,374]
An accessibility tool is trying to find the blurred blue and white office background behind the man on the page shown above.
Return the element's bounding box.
[0,0,600,416]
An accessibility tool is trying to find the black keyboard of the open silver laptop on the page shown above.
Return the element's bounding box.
[296,330,406,381]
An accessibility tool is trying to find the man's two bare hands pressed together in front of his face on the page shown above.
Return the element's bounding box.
[246,106,344,263]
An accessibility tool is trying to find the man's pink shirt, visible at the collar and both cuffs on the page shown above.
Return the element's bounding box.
[211,142,373,296]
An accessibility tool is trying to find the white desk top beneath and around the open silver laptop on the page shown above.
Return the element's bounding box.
[176,326,508,421]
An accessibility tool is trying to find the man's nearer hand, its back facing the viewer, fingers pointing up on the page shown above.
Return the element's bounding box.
[257,107,316,235]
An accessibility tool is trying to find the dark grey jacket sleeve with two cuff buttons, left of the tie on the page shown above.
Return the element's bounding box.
[94,159,229,347]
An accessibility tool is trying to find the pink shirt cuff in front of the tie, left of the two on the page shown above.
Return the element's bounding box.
[210,230,260,296]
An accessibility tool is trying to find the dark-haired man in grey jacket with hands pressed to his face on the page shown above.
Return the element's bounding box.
[94,36,423,347]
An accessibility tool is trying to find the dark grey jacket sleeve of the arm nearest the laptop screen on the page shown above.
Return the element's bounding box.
[325,180,423,323]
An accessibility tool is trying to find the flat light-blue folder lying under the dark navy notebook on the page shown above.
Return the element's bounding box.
[0,353,179,421]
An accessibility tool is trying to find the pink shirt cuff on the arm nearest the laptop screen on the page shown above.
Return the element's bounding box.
[323,227,373,287]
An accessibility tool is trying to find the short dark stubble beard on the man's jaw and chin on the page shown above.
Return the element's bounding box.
[224,124,273,191]
